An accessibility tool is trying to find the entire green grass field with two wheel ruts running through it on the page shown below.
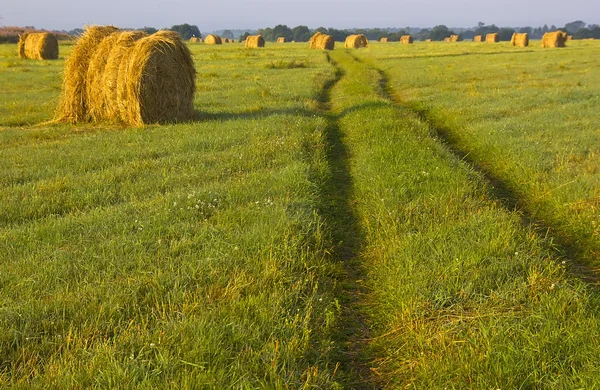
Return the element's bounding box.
[0,41,600,389]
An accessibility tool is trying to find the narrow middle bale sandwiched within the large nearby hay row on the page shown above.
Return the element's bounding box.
[102,31,148,120]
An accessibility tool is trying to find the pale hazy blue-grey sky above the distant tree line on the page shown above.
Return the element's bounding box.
[0,0,600,32]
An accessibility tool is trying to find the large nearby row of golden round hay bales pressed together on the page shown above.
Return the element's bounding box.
[57,26,196,126]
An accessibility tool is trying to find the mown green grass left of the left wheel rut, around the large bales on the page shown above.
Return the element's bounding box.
[0,45,346,388]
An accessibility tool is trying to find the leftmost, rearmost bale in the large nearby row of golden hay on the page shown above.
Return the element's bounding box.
[56,26,118,123]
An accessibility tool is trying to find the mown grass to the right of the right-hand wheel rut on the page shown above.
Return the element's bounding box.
[356,41,600,268]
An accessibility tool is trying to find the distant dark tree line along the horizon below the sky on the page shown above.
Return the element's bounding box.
[0,20,600,43]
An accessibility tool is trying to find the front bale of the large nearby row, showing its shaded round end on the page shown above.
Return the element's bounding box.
[117,30,196,126]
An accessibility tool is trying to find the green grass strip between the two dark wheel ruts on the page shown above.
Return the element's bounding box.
[332,45,600,389]
